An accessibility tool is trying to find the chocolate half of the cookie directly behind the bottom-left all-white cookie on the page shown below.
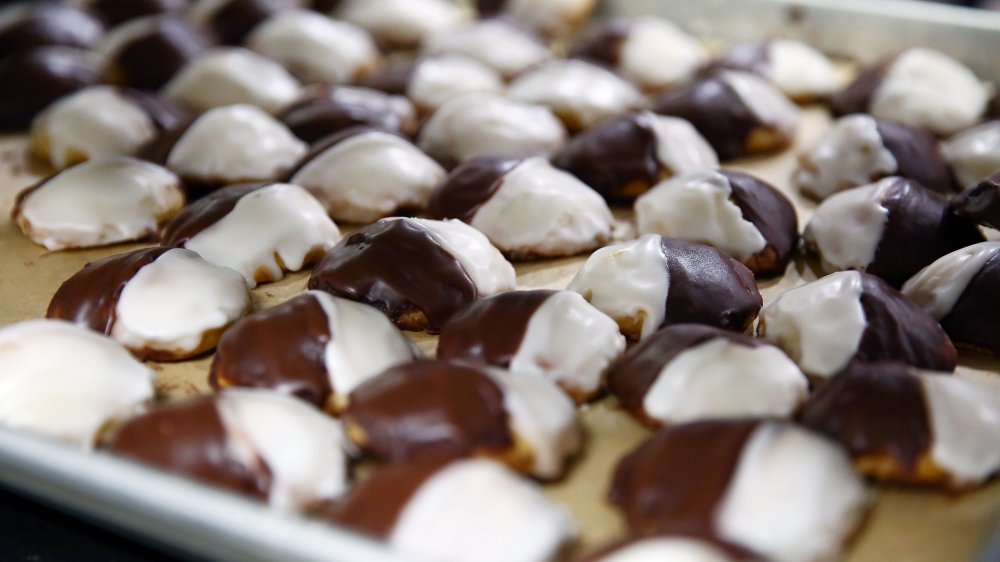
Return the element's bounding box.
[45,246,171,334]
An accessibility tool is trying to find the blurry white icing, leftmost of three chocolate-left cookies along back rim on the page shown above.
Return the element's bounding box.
[618,17,708,89]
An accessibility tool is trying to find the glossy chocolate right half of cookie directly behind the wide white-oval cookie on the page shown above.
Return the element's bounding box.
[662,238,763,332]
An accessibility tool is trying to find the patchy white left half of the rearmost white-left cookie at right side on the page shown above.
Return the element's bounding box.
[792,114,898,199]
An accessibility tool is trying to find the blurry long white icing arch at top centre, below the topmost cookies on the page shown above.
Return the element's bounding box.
[424,19,552,78]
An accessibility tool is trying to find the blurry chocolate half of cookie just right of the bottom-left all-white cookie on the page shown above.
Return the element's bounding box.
[110,396,271,497]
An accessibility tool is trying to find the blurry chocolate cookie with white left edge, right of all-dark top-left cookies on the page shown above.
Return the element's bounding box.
[94,16,213,90]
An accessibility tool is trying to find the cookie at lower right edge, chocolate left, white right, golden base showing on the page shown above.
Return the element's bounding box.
[801,363,1000,489]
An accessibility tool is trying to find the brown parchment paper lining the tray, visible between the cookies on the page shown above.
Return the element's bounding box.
[0,108,1000,562]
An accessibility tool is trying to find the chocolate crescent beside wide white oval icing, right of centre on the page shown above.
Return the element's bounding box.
[608,324,766,426]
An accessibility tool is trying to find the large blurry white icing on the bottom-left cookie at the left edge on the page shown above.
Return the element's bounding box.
[0,320,153,449]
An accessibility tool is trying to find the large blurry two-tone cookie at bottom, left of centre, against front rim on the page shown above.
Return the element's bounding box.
[327,458,576,562]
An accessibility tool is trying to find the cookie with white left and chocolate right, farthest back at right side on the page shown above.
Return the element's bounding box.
[792,114,955,200]
